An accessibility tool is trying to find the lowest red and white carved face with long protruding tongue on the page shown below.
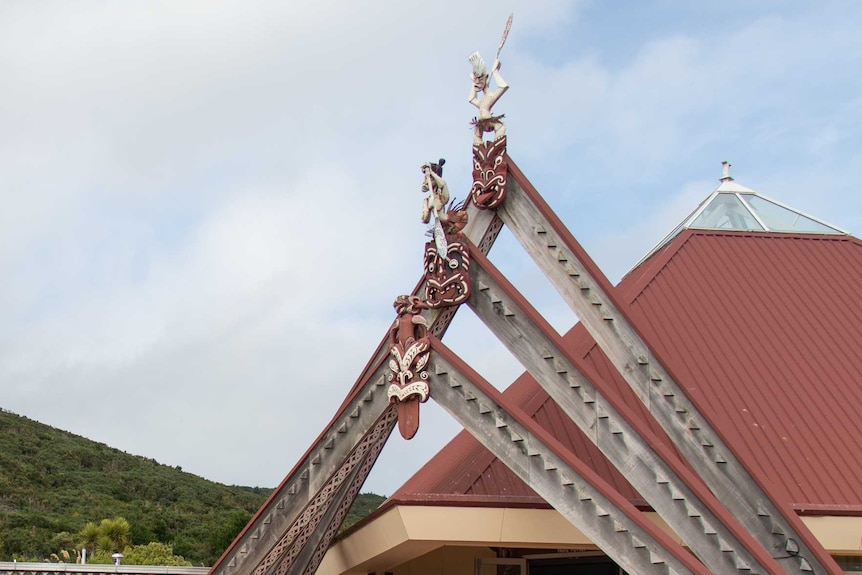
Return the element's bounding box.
[387,295,431,439]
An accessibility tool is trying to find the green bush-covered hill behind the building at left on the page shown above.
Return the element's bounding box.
[0,410,383,565]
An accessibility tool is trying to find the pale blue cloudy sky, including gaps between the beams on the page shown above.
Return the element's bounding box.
[0,0,862,495]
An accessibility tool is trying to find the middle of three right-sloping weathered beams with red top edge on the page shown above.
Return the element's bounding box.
[468,242,783,575]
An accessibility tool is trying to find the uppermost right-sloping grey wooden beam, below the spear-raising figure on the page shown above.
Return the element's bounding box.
[498,159,843,575]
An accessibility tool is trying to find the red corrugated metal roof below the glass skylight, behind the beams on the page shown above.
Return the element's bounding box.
[392,230,862,515]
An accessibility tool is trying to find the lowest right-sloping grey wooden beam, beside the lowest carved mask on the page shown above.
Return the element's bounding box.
[430,338,709,575]
